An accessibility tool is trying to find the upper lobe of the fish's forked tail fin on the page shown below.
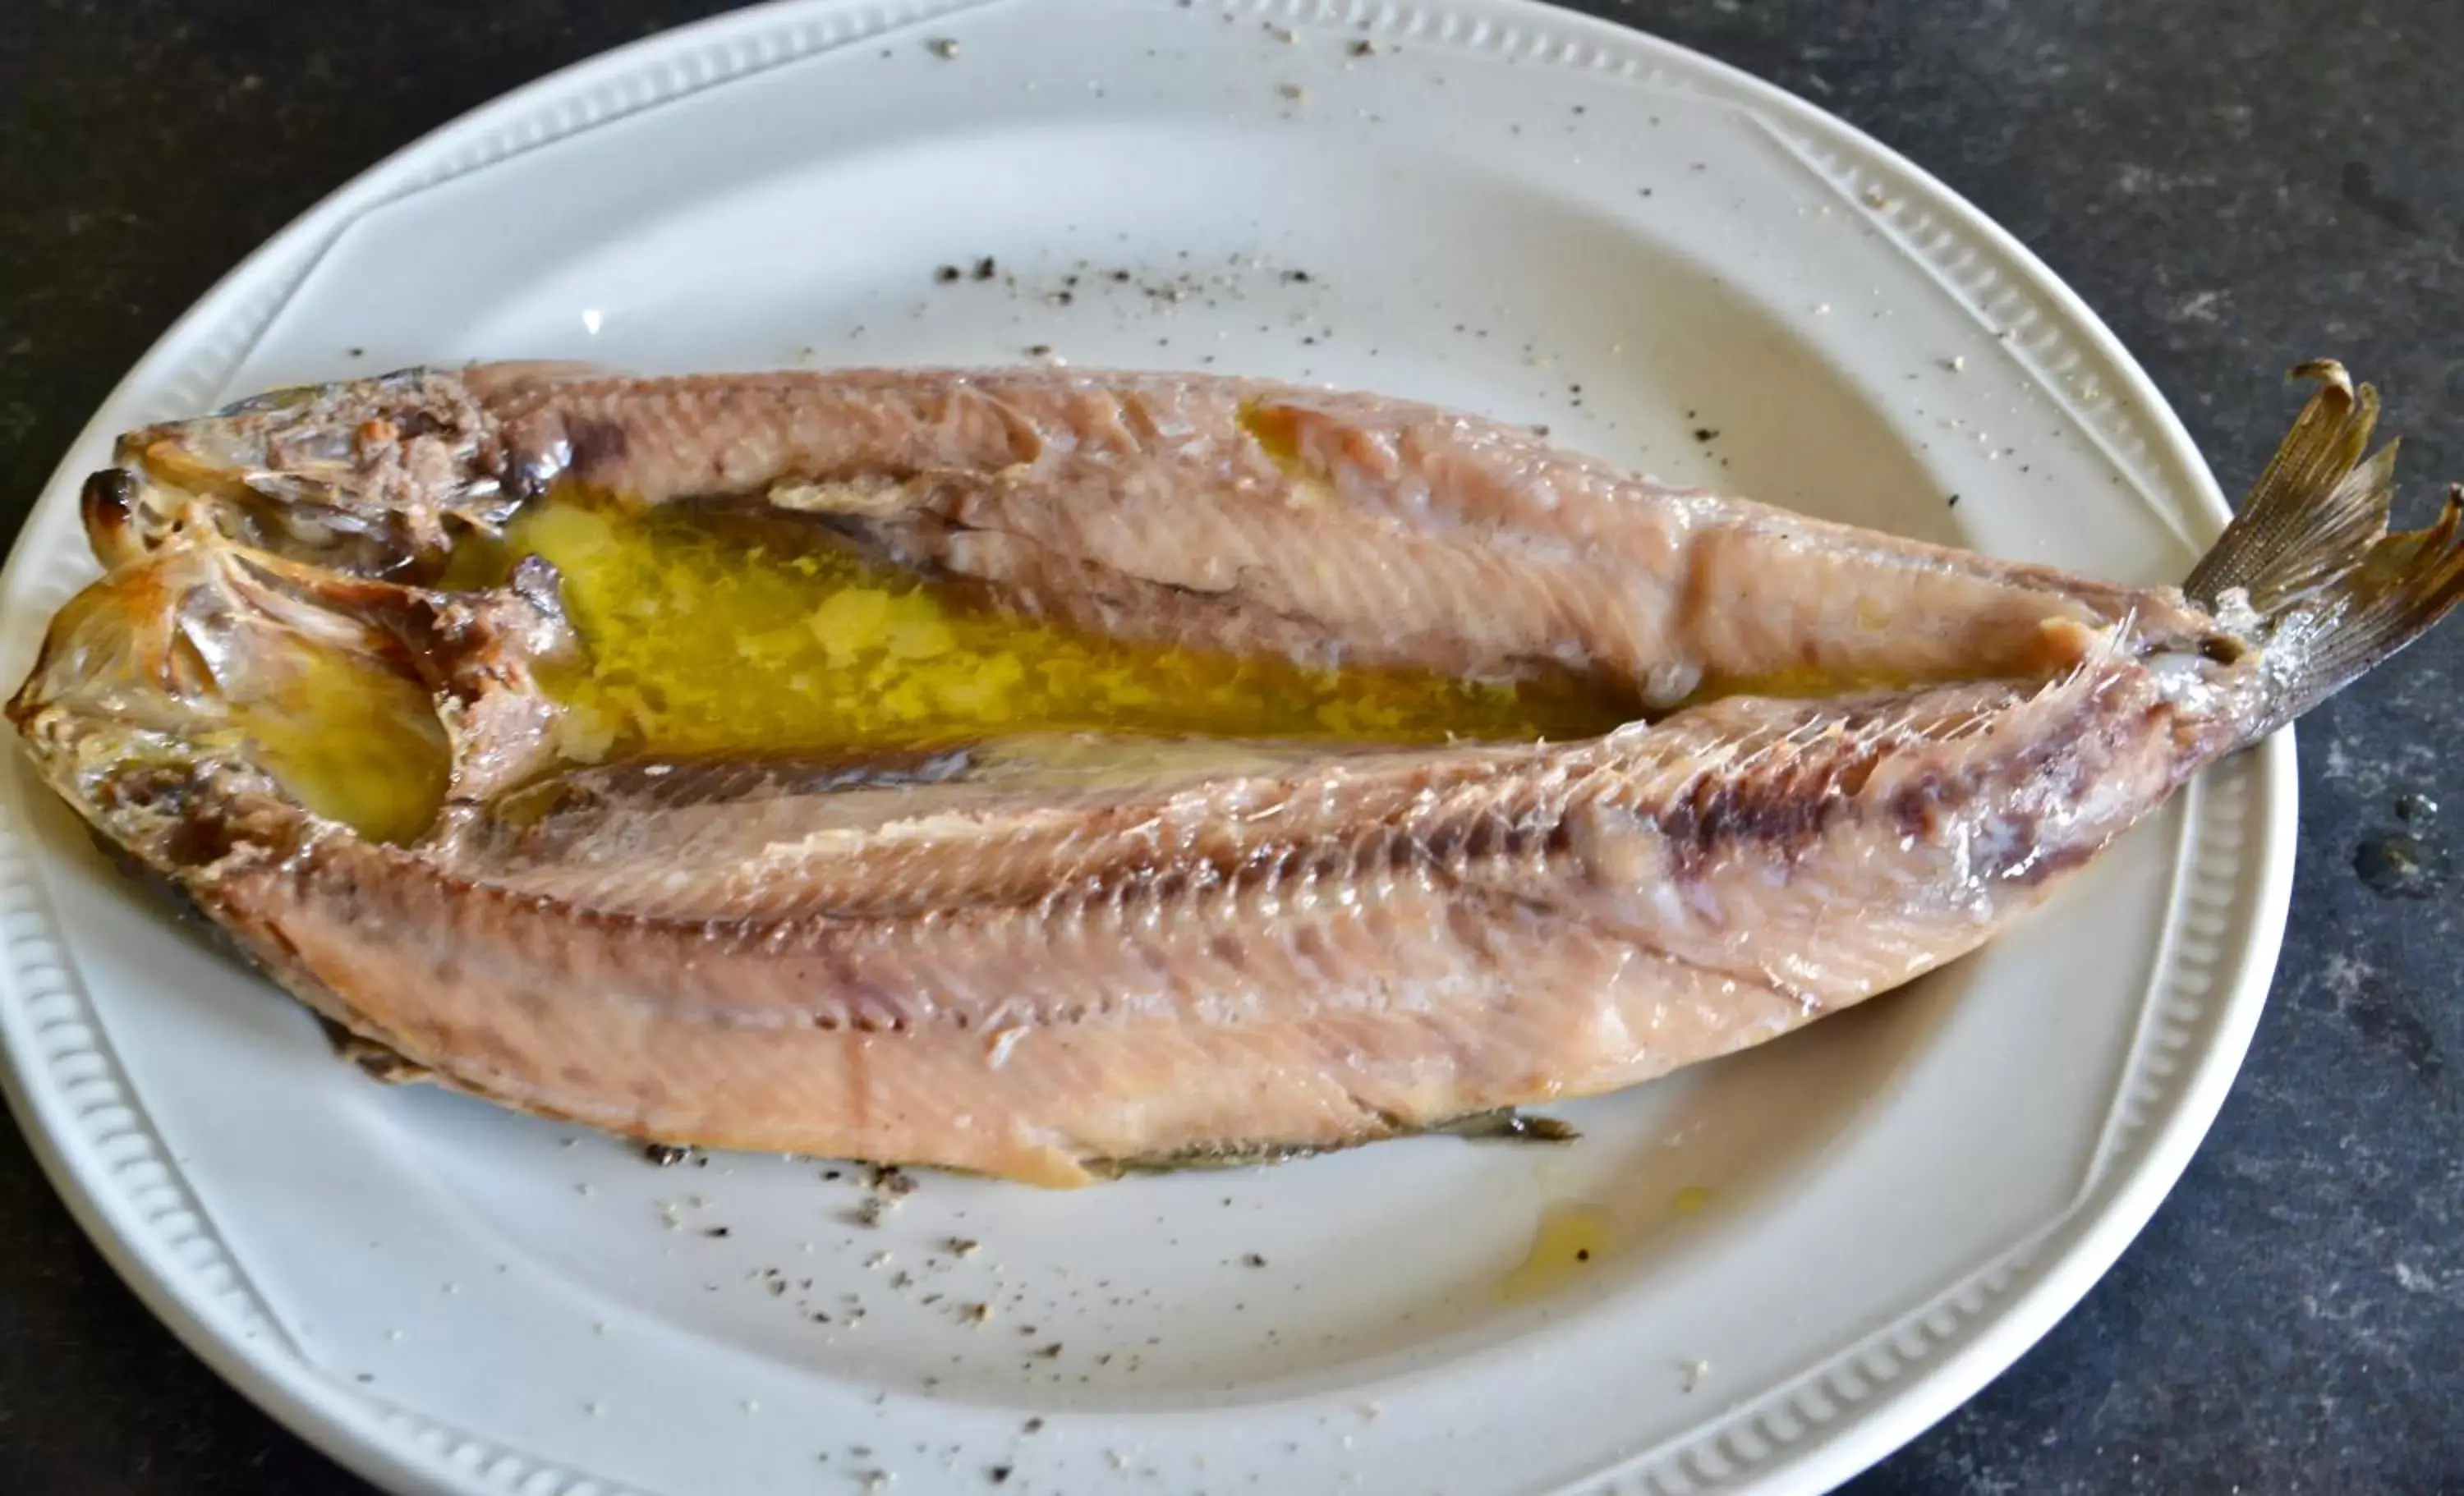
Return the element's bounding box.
[2181,360,2395,618]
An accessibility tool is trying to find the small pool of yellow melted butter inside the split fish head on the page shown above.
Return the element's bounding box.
[232,648,448,843]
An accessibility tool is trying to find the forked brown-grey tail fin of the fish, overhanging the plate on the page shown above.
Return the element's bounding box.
[2183,360,2464,741]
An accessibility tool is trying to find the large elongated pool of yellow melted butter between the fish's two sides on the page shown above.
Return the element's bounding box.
[493,495,1631,759]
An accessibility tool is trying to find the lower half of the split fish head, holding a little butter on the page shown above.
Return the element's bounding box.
[7,535,579,846]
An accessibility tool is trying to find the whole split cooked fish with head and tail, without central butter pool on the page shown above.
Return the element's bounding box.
[10,365,2464,1186]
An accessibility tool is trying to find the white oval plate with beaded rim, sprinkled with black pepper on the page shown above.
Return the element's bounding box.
[0,0,2294,1496]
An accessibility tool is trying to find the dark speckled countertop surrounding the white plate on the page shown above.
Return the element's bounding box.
[0,0,2464,1496]
